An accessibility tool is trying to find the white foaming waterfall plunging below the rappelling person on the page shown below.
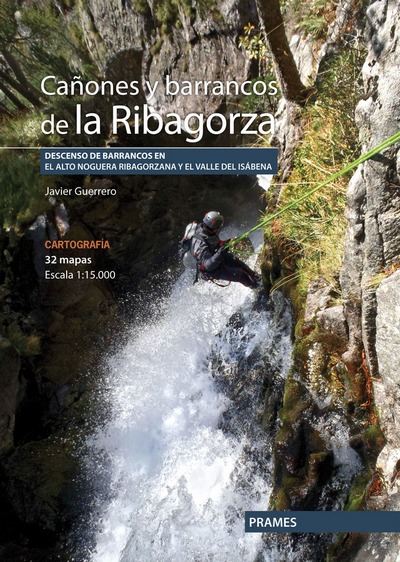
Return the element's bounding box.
[88,266,291,562]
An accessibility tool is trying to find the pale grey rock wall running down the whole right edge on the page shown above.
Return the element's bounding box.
[341,0,400,560]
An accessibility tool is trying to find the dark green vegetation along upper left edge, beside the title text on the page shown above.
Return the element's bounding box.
[0,0,94,229]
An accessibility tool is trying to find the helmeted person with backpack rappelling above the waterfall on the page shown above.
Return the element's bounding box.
[181,211,262,289]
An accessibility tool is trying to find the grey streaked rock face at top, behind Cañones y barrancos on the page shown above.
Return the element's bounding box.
[80,0,256,117]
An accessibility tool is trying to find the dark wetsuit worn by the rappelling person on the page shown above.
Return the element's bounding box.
[191,223,260,289]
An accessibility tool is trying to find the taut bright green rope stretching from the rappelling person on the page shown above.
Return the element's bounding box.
[227,131,400,248]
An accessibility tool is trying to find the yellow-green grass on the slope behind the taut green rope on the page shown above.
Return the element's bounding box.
[267,49,361,295]
